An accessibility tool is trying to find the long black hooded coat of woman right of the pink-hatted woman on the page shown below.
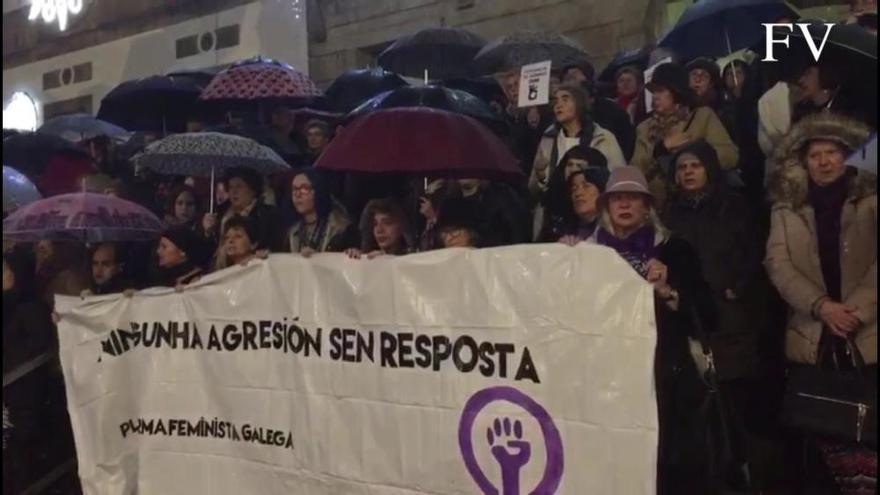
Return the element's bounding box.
[663,141,761,379]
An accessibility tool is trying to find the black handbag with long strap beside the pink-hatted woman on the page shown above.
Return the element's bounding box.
[689,305,754,494]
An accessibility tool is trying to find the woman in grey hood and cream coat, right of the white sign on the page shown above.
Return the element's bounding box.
[529,85,626,200]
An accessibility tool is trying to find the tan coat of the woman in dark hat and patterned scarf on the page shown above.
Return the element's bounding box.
[631,107,739,205]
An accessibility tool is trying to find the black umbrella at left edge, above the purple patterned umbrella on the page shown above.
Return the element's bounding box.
[3,132,89,179]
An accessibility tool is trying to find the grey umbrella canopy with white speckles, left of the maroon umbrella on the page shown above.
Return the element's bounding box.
[132,132,290,177]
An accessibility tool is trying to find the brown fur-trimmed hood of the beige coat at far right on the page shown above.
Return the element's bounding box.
[769,112,877,209]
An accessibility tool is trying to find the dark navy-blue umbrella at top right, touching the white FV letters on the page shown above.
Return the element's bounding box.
[658,0,799,60]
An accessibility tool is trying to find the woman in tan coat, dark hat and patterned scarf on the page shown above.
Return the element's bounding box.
[631,63,739,206]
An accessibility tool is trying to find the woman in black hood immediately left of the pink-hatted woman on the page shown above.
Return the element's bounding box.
[537,146,609,244]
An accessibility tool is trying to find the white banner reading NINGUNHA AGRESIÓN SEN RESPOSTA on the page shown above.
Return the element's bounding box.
[56,245,657,495]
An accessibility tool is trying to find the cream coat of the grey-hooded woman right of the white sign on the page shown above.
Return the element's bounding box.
[529,124,626,199]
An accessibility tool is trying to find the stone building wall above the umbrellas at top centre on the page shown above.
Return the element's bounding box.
[308,0,665,85]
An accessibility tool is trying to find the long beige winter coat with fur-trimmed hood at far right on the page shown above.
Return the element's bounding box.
[764,114,877,364]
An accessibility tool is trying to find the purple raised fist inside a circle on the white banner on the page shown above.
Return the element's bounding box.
[458,387,565,495]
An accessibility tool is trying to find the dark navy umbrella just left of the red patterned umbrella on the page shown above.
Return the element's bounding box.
[98,76,204,134]
